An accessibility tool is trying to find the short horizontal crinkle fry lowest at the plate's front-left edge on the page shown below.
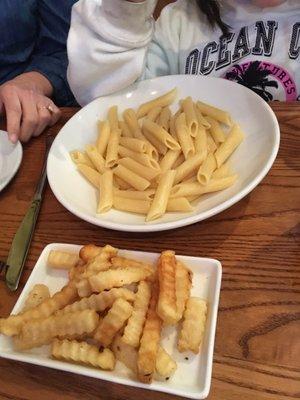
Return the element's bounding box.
[51,339,115,371]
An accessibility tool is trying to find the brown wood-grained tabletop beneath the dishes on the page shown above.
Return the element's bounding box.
[0,103,300,400]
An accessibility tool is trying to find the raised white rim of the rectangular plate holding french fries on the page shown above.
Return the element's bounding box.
[0,243,222,399]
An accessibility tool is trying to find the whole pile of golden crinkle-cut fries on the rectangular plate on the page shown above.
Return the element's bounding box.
[0,245,207,383]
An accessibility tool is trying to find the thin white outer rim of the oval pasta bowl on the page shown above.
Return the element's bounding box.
[47,75,280,232]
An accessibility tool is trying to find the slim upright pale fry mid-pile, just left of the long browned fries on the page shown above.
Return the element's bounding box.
[123,281,151,347]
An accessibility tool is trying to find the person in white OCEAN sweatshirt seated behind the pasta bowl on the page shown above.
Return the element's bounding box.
[68,0,300,105]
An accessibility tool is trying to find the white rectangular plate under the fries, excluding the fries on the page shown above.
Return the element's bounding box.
[0,244,222,399]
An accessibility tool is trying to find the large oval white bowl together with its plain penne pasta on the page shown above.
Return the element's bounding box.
[47,75,280,232]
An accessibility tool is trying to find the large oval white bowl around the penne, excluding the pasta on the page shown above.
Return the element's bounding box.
[47,75,280,232]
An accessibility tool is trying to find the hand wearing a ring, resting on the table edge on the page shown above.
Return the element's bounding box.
[0,72,61,143]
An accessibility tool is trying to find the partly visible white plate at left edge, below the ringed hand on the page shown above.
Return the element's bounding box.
[0,130,23,192]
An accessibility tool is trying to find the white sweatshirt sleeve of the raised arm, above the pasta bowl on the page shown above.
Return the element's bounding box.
[68,0,156,105]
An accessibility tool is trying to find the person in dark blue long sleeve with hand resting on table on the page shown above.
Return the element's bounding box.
[0,0,76,142]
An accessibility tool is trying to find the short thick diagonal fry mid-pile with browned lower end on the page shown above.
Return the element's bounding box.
[94,298,132,347]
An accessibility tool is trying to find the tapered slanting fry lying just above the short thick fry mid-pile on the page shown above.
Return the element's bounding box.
[57,288,135,314]
